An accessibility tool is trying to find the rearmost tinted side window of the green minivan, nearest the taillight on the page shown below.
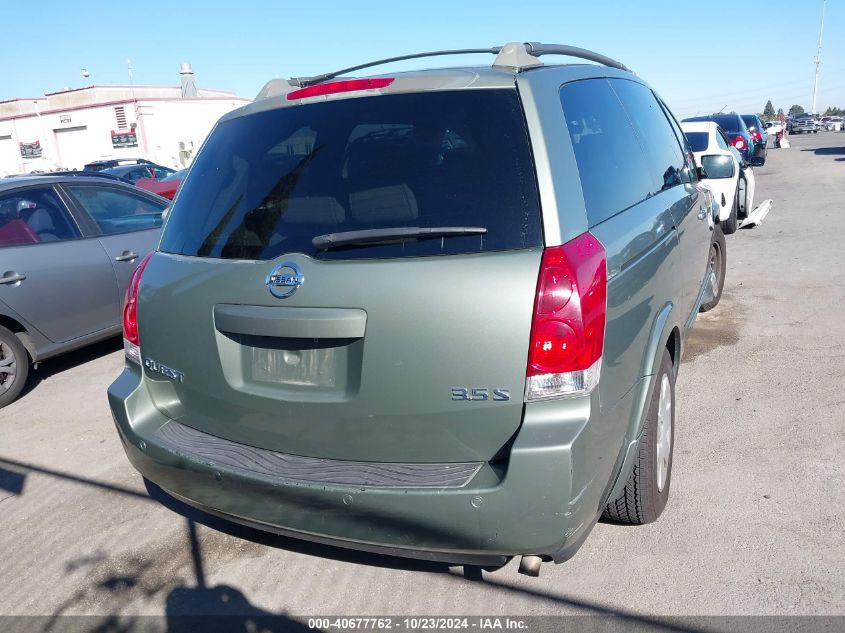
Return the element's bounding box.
[560,79,654,226]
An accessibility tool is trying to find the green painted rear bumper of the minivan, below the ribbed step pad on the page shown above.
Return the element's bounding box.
[108,367,608,563]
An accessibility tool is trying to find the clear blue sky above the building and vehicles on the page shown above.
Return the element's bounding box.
[0,0,845,117]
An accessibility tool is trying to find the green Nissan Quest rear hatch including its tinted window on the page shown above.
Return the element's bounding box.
[143,88,543,462]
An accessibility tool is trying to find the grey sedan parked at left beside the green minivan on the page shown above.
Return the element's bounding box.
[0,175,167,407]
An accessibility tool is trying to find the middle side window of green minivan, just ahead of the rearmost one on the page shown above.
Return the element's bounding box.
[610,79,689,193]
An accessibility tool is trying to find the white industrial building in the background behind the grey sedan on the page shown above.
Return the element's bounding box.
[0,65,250,177]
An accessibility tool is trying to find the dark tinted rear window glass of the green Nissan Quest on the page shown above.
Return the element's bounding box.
[161,90,542,260]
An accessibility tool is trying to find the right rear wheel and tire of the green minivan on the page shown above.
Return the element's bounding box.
[604,349,675,525]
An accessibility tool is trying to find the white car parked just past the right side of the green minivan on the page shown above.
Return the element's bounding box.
[681,121,747,235]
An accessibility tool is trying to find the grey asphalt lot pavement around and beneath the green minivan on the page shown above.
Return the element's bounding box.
[0,132,845,624]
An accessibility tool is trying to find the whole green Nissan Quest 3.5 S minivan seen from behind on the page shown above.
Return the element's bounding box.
[108,43,724,575]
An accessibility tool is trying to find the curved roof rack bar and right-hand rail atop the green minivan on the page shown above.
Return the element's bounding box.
[288,42,630,88]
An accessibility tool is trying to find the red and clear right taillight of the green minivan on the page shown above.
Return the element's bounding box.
[525,233,607,400]
